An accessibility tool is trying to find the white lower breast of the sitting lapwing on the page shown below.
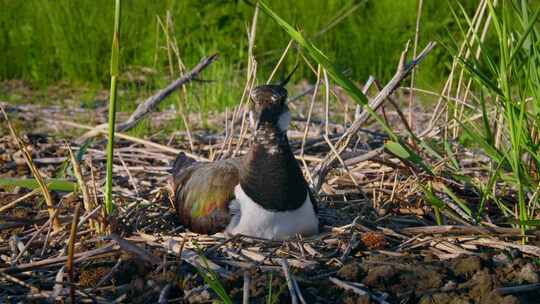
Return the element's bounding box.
[225,185,319,240]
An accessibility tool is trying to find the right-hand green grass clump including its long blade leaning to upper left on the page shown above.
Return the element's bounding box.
[261,0,540,235]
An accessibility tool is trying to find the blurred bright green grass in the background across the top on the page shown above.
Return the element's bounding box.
[0,0,477,88]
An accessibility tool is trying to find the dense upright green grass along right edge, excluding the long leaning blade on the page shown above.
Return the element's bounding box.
[454,0,540,233]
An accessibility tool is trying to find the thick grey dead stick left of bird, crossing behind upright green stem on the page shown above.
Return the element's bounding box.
[78,54,218,142]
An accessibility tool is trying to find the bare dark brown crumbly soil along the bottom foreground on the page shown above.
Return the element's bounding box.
[64,245,540,304]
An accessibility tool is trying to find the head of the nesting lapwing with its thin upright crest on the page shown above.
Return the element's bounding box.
[249,68,296,132]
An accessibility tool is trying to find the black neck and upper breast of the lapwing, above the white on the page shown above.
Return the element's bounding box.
[240,123,308,211]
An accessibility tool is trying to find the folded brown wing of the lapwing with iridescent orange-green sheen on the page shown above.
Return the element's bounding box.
[170,158,240,234]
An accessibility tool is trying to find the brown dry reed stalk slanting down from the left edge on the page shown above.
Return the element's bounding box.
[0,105,62,232]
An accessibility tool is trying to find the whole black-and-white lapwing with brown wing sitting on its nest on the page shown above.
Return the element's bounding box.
[169,79,319,240]
